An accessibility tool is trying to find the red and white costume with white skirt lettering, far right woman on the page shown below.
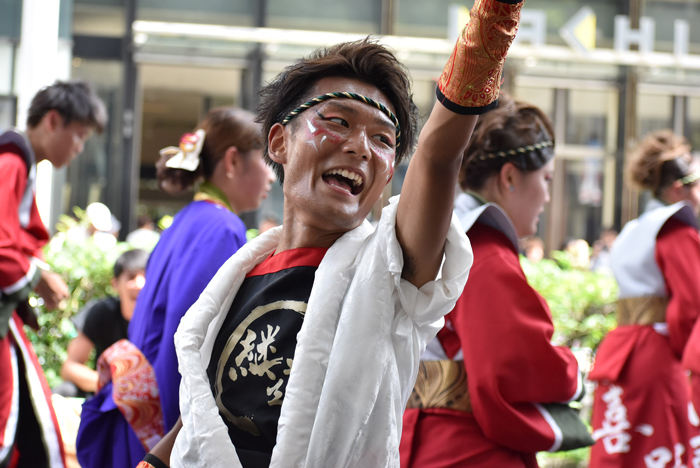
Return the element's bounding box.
[590,206,700,468]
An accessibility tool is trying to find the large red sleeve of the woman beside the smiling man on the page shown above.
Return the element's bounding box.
[449,224,581,452]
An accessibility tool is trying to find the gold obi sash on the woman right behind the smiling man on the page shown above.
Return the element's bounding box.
[406,360,472,412]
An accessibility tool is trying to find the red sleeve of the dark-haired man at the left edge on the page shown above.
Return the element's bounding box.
[0,153,37,294]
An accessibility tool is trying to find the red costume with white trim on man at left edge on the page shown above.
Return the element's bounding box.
[0,131,65,468]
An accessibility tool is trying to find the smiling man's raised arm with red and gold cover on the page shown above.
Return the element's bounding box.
[396,0,523,287]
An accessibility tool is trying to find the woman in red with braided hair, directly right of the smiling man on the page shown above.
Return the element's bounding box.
[401,96,592,468]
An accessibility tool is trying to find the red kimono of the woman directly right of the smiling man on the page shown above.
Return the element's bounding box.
[401,195,582,468]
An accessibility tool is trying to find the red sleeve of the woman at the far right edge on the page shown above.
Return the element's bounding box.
[656,219,700,364]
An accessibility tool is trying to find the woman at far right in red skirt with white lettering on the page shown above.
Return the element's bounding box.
[590,130,700,468]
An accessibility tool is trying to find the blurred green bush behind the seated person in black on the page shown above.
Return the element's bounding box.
[25,208,129,387]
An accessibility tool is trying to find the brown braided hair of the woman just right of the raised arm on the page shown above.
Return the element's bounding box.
[459,93,554,190]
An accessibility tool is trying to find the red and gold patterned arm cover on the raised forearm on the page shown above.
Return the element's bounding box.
[437,0,523,115]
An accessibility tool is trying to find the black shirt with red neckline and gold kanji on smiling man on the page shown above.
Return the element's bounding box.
[207,248,326,468]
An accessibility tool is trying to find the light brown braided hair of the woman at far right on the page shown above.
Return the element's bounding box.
[627,130,693,198]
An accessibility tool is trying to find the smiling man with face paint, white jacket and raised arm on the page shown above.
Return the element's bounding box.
[139,0,521,468]
